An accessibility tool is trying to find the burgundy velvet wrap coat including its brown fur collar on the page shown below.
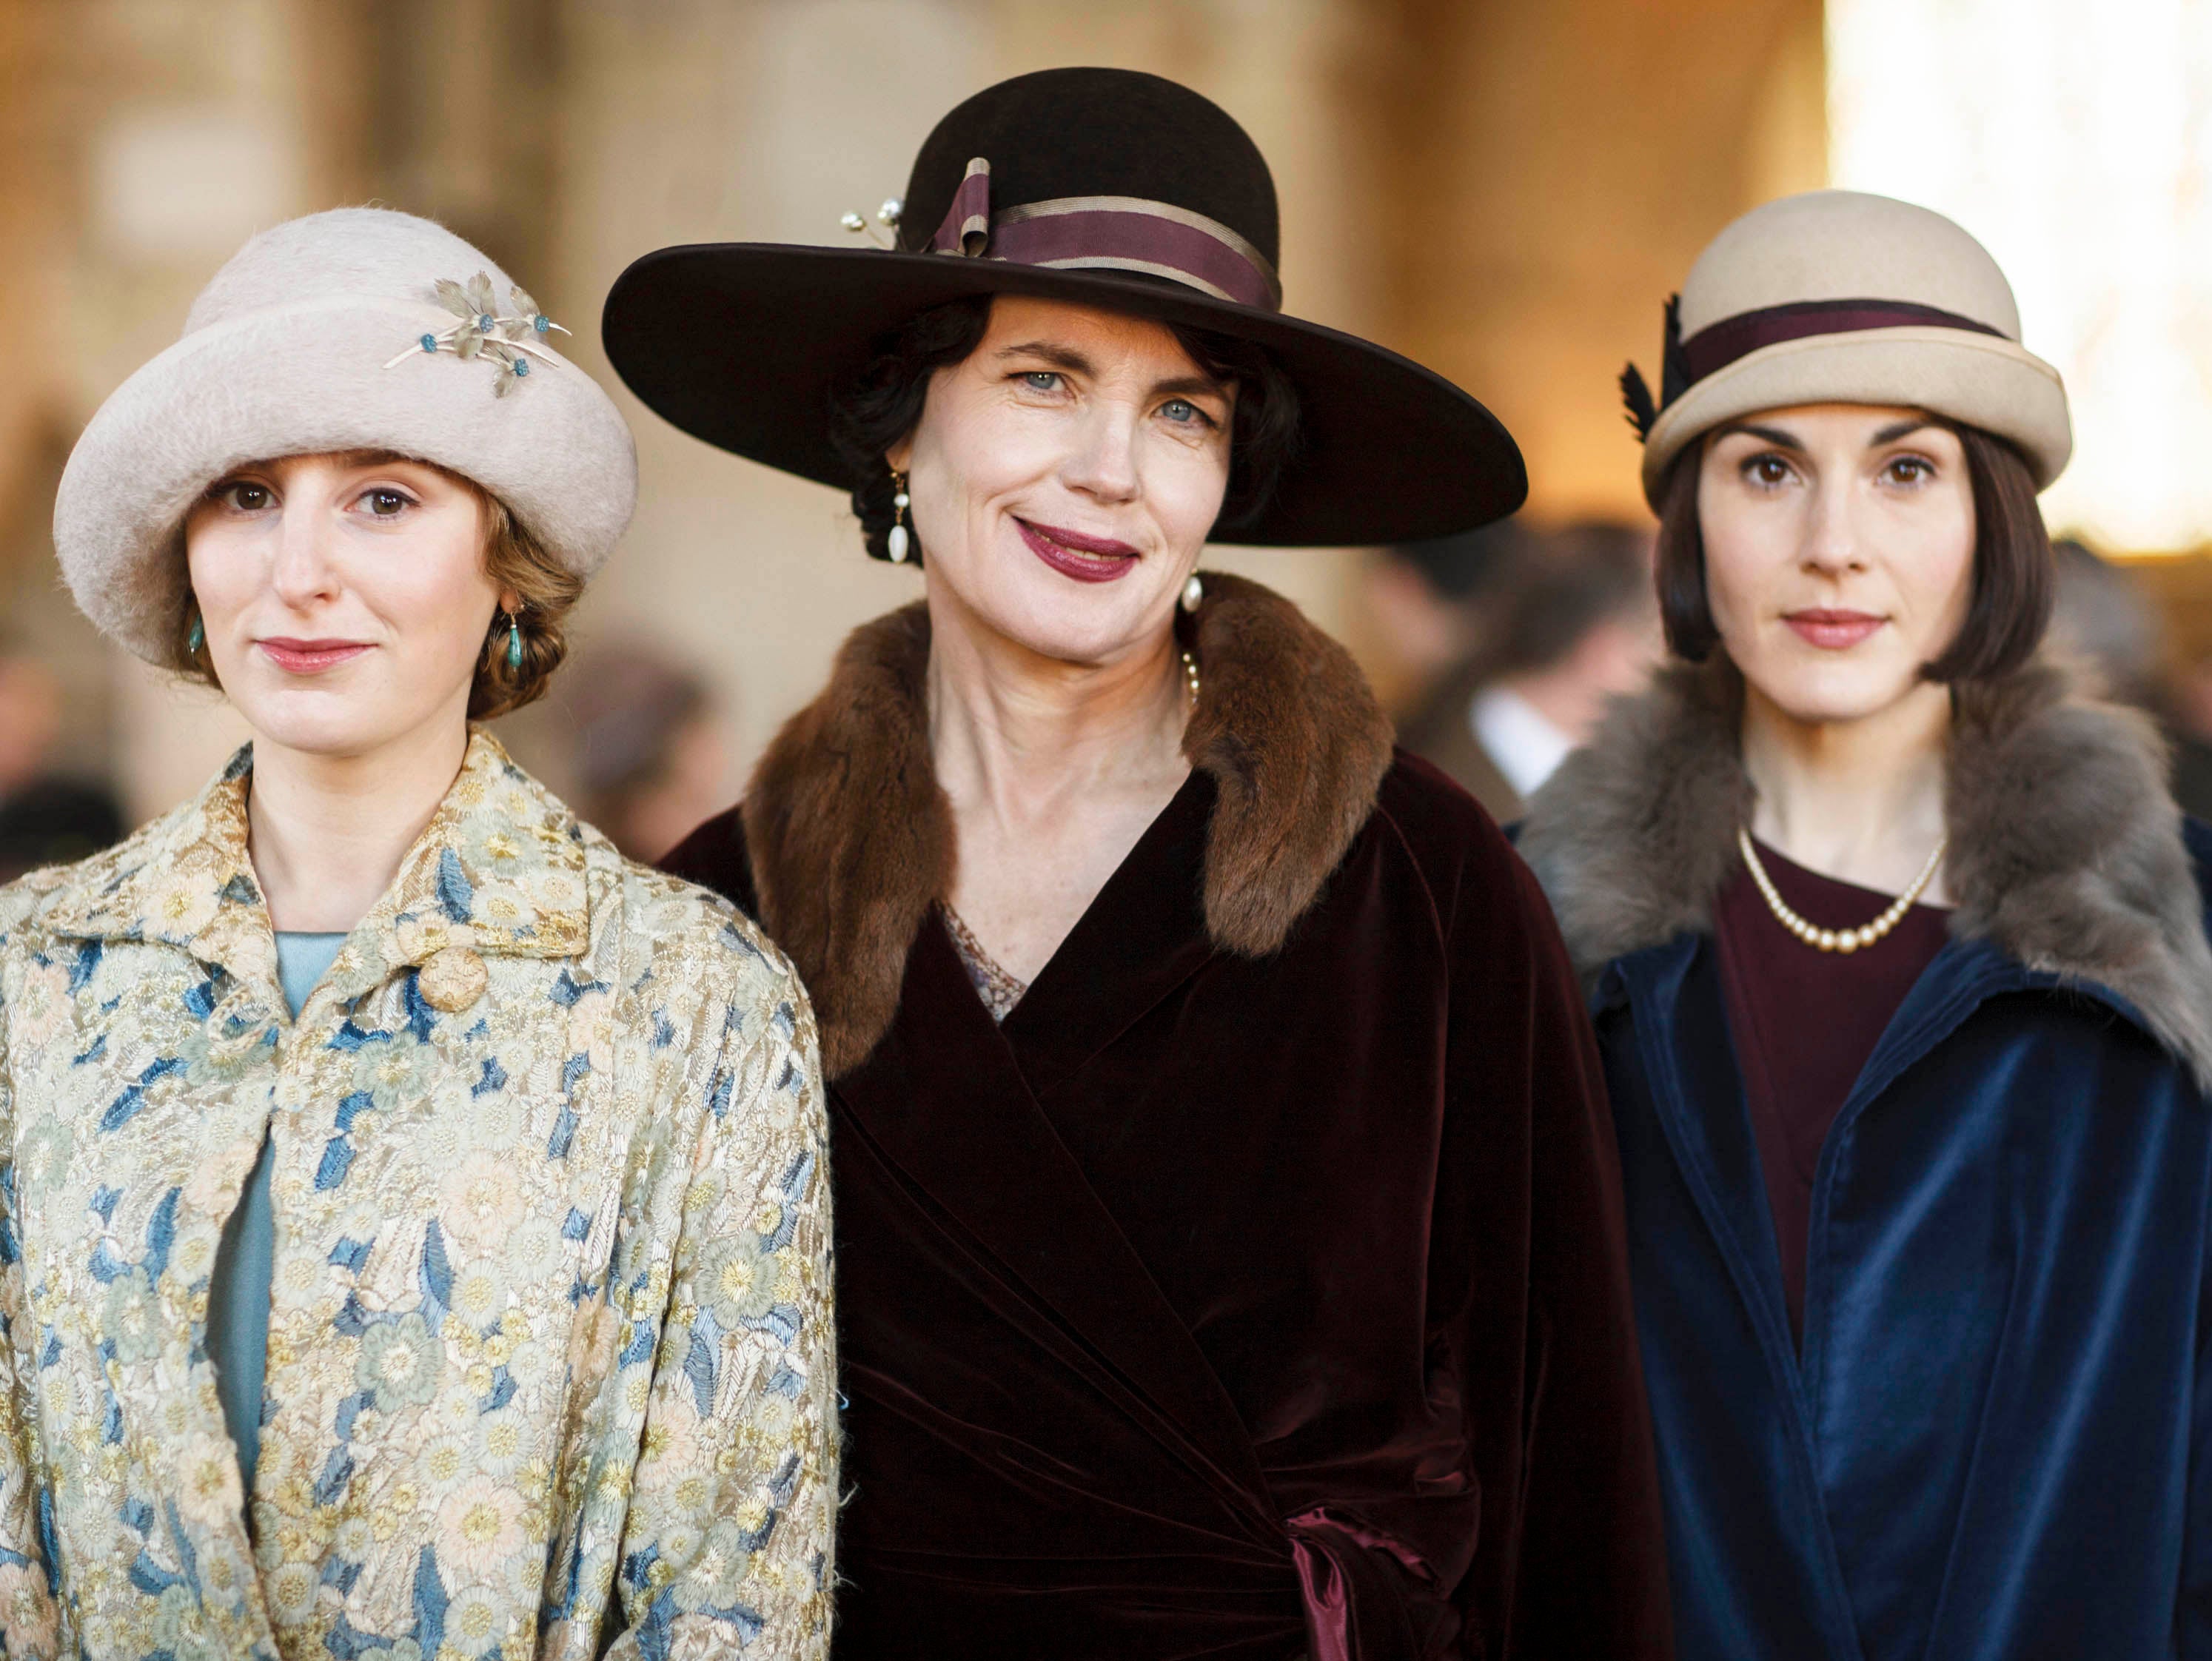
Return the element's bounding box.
[668,575,1670,1661]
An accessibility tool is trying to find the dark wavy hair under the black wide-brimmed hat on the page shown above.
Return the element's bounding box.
[830,294,1298,564]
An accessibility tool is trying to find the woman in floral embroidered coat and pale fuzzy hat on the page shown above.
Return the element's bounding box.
[0,208,836,1661]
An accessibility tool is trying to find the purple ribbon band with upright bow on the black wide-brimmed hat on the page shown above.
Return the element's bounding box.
[929,157,1283,312]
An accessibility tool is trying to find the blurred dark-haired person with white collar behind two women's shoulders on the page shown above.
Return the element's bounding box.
[1398,520,1659,825]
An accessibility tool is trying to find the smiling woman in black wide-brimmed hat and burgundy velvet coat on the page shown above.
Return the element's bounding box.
[606,69,1666,1661]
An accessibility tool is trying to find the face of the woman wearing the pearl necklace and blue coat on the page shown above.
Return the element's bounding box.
[1697,405,1975,723]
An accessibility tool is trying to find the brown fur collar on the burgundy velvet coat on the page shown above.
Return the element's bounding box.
[743,573,1391,1077]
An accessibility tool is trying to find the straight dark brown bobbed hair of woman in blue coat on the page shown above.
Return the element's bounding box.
[1657,418,2055,683]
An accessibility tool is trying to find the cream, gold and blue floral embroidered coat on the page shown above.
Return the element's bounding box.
[0,734,836,1661]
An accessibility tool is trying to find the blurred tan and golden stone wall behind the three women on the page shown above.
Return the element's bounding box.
[0,0,2201,831]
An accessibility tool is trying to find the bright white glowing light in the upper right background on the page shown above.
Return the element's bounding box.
[1827,0,2212,553]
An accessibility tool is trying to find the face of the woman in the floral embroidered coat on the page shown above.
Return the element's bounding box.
[184,456,502,756]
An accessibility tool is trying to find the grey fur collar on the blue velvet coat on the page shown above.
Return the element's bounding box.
[1520,659,2212,1090]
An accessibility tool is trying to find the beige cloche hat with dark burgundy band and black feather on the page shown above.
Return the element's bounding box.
[1621,190,2073,509]
